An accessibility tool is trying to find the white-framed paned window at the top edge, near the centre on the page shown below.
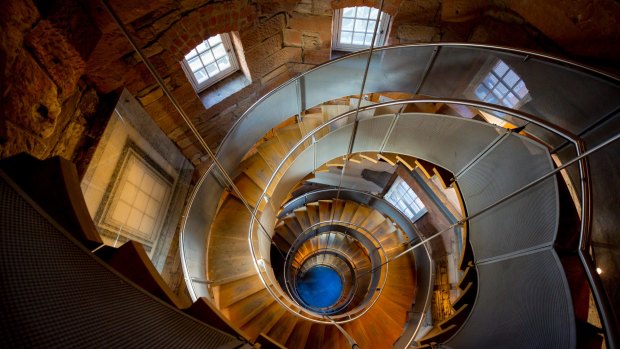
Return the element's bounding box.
[332,6,390,51]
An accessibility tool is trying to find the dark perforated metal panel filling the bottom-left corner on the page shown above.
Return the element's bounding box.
[0,177,242,348]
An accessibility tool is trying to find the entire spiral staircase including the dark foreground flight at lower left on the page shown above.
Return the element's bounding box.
[0,40,620,349]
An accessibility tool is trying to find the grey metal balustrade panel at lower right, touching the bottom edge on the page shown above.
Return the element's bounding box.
[444,249,575,349]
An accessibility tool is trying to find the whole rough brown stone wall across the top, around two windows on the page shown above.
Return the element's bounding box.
[0,0,620,174]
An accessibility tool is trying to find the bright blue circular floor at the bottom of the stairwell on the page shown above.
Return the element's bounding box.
[297,265,342,308]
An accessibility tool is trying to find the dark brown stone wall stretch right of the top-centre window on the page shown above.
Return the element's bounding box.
[389,0,620,63]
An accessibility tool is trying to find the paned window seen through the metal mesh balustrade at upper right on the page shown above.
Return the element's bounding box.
[475,60,529,108]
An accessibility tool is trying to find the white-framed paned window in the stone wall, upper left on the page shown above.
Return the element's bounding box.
[182,34,239,92]
